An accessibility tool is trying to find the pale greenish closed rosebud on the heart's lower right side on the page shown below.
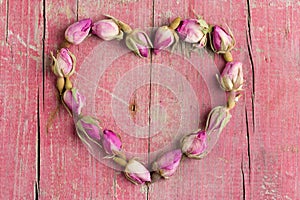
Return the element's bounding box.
[205,106,231,135]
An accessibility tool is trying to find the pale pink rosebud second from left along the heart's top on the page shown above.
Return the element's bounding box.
[92,19,123,40]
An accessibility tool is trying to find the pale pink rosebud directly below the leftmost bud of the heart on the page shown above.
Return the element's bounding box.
[63,88,85,116]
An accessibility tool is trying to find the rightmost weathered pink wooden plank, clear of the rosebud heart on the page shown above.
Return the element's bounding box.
[249,1,300,199]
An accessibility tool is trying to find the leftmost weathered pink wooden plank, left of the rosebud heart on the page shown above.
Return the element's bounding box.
[0,0,43,199]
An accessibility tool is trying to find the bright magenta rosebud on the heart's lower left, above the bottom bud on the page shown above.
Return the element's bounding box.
[102,129,122,155]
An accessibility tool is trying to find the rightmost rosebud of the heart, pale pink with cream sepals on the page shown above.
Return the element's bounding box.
[218,62,244,92]
